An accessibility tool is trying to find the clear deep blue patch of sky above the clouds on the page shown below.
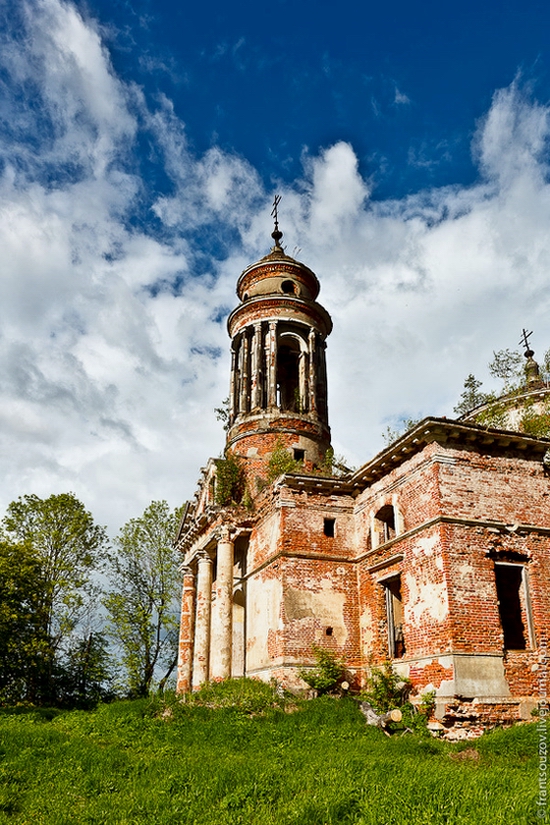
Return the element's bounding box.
[90,0,550,198]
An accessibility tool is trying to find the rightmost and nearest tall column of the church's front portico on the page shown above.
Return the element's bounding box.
[210,527,234,679]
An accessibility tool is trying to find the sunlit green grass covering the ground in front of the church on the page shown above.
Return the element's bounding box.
[0,683,541,825]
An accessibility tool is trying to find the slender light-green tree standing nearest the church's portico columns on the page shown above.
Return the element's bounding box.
[104,501,185,696]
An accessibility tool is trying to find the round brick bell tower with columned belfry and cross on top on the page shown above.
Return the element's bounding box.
[227,197,332,477]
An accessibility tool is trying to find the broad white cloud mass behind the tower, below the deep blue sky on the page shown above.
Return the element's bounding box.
[0,0,550,530]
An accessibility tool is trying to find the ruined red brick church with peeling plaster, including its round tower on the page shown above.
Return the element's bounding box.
[177,214,550,724]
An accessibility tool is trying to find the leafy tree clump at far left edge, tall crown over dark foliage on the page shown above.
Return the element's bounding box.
[0,493,107,704]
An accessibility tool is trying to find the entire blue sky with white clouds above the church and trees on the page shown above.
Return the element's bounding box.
[0,0,550,531]
